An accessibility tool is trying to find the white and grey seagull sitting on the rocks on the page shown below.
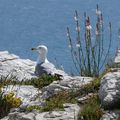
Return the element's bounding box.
[31,45,67,77]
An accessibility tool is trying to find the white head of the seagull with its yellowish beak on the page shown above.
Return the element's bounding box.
[31,45,48,55]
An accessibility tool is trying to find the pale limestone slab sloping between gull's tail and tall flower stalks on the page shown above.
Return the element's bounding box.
[42,76,93,99]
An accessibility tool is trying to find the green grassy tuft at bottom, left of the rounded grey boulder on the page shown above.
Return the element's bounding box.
[78,95,103,120]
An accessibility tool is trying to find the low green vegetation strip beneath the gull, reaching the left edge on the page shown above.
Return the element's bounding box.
[0,74,60,89]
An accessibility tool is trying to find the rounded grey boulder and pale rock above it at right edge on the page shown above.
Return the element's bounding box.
[99,49,120,109]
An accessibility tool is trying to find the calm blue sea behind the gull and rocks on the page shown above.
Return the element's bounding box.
[0,0,120,73]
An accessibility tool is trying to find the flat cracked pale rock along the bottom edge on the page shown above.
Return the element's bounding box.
[1,103,80,120]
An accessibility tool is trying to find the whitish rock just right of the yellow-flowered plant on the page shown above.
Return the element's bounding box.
[2,85,40,106]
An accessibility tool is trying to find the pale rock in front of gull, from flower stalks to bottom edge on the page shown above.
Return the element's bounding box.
[1,76,92,120]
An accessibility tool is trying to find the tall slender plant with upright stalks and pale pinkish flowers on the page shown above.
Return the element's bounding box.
[67,5,112,77]
